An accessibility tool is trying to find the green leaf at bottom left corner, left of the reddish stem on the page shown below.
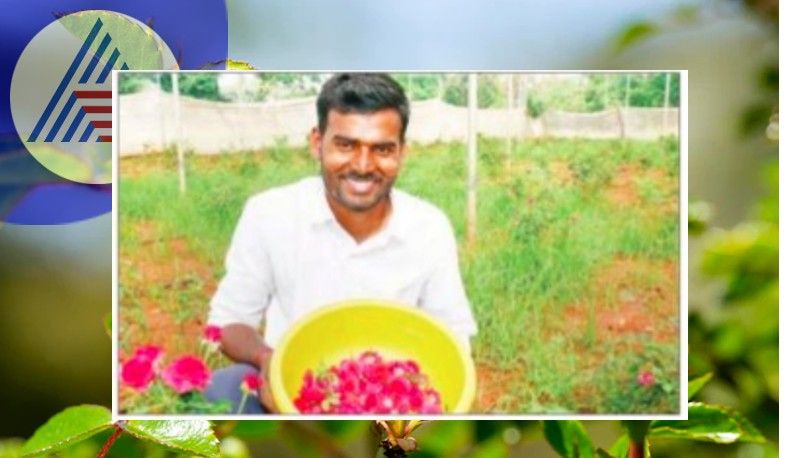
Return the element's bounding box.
[20,405,113,456]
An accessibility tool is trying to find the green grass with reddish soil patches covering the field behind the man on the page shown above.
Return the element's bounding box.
[119,138,679,413]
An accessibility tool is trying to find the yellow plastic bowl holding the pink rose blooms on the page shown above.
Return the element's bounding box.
[269,300,475,413]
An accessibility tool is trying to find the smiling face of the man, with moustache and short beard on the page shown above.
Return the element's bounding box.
[310,109,405,212]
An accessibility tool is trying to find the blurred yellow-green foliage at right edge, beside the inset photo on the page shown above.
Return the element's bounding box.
[690,164,779,414]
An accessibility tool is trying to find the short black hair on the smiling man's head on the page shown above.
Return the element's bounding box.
[317,73,409,141]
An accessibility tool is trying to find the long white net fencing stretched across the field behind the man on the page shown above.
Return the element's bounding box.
[118,89,679,155]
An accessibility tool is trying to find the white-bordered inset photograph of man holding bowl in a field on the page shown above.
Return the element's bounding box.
[113,71,686,418]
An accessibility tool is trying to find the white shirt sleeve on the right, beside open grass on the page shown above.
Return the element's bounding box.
[420,216,478,348]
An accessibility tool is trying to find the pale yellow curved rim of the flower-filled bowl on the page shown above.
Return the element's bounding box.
[269,298,477,416]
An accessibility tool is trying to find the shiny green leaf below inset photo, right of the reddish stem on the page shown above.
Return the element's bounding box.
[123,420,220,456]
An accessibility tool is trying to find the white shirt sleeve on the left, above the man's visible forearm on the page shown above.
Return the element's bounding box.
[208,200,274,328]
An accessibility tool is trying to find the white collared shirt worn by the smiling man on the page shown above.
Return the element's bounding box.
[209,177,477,348]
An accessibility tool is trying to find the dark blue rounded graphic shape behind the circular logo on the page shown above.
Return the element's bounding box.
[0,0,228,225]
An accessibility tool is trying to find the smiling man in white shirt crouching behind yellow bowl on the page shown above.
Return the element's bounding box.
[206,74,477,413]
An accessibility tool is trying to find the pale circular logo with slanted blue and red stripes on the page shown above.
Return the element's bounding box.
[11,10,177,184]
